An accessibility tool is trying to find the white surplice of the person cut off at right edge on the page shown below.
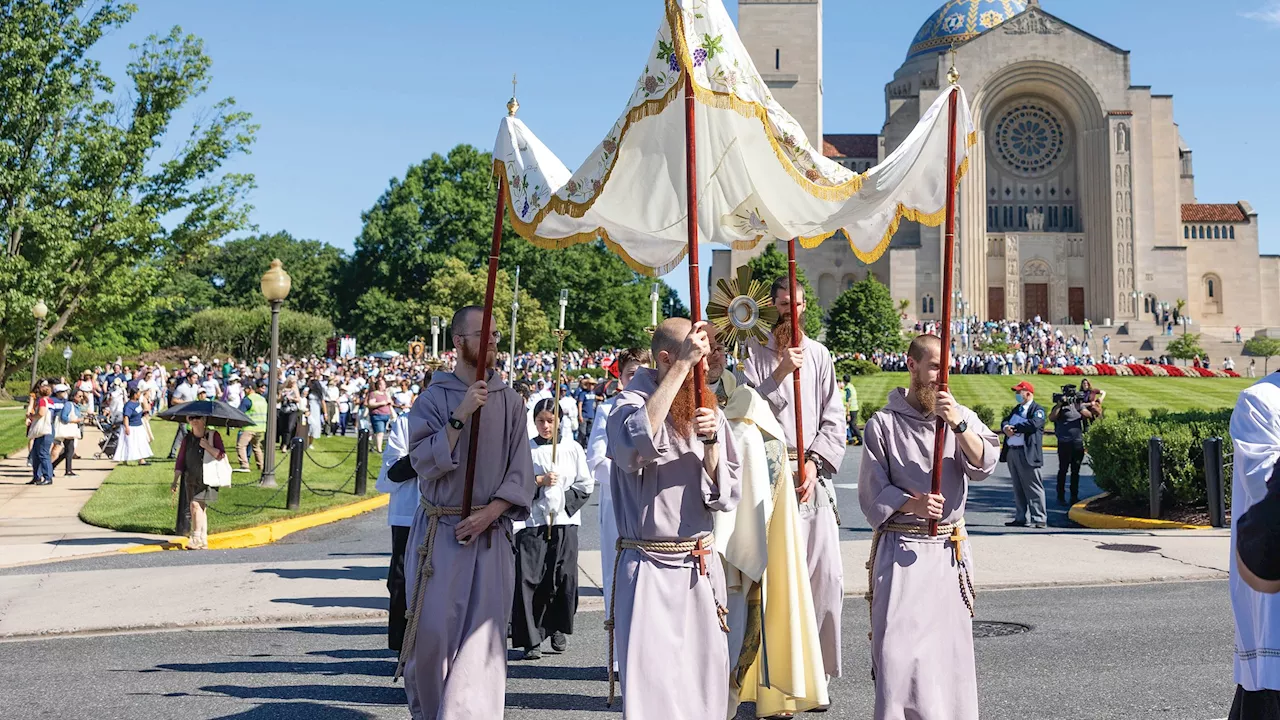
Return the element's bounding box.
[1230,373,1280,692]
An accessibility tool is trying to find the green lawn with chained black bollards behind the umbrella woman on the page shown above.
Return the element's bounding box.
[81,420,381,534]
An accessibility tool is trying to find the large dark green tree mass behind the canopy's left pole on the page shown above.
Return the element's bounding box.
[344,145,687,347]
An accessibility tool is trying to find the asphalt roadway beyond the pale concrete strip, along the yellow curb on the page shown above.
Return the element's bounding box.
[0,447,1100,577]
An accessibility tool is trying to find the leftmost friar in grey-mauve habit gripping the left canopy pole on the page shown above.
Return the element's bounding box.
[401,306,536,720]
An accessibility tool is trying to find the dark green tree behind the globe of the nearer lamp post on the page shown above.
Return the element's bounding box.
[196,232,346,319]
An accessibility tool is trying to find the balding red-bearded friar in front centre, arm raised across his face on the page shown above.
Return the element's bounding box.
[608,318,740,720]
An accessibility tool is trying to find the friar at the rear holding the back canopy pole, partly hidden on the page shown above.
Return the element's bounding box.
[744,277,846,702]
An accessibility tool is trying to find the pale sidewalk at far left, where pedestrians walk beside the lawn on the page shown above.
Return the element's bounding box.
[0,427,168,568]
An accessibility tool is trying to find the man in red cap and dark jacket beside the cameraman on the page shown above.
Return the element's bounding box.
[1000,380,1048,528]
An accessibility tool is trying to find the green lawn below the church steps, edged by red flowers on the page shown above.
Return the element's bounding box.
[854,373,1257,415]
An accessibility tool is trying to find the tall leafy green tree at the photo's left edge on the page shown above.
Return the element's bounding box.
[0,0,256,382]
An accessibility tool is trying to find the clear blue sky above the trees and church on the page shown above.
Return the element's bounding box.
[97,0,1280,300]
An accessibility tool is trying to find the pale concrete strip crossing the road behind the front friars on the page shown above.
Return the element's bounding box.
[0,520,1230,639]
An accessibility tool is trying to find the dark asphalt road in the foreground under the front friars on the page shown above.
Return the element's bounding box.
[0,582,1234,720]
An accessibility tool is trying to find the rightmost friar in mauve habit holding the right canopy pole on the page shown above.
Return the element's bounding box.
[858,334,1000,720]
